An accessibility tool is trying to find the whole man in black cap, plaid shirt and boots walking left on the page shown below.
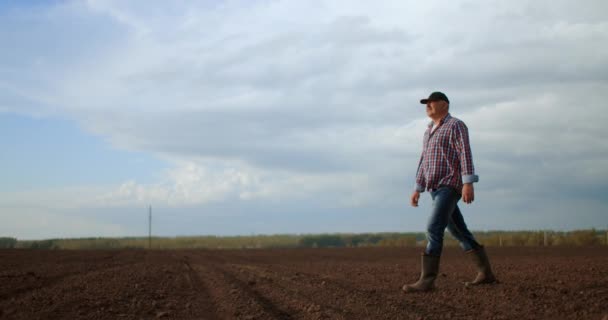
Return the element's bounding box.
[403,92,497,293]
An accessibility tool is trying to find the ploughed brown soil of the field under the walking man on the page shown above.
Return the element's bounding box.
[0,247,608,320]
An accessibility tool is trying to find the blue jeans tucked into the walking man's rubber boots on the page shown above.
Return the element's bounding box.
[425,187,481,256]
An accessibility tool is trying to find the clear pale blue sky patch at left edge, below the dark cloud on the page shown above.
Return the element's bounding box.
[0,113,166,191]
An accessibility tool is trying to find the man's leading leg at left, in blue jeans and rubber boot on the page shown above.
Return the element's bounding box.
[402,188,459,293]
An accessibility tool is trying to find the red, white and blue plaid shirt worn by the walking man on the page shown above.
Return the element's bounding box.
[416,113,479,192]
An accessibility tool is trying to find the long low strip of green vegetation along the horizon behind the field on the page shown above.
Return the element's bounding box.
[0,229,608,250]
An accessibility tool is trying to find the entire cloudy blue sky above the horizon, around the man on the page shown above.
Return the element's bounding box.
[0,0,608,239]
